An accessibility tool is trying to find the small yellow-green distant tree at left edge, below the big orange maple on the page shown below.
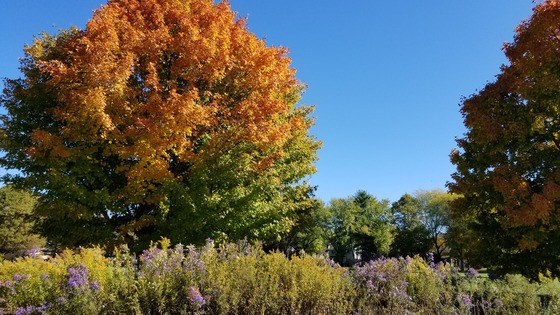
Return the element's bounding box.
[0,186,45,258]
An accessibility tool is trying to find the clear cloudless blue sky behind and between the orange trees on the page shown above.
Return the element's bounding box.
[0,0,534,201]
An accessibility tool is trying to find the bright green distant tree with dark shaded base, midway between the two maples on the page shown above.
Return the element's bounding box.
[327,190,393,265]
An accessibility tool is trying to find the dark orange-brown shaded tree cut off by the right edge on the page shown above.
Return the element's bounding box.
[449,1,560,275]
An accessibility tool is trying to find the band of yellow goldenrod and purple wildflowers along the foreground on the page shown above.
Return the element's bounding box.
[0,239,560,314]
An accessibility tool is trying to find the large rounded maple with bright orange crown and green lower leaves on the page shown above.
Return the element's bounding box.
[1,0,320,251]
